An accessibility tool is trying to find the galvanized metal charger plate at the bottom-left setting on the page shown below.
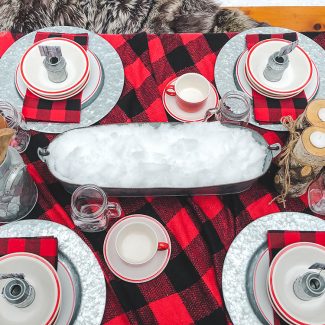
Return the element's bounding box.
[0,220,106,325]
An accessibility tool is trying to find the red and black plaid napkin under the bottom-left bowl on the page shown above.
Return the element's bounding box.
[0,237,58,269]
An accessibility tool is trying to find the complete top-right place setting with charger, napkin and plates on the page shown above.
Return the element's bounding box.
[215,27,325,131]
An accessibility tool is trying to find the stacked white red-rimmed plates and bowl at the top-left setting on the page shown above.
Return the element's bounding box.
[16,38,102,102]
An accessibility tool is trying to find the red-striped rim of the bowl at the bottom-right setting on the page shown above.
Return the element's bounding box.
[268,242,325,325]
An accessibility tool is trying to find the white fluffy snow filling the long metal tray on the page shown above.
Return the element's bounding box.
[48,122,266,188]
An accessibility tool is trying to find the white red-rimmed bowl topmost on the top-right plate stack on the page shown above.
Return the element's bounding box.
[246,39,312,95]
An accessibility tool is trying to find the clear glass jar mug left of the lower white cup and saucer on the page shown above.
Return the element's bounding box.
[71,185,122,232]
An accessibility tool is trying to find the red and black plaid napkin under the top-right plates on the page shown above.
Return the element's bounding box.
[246,33,307,124]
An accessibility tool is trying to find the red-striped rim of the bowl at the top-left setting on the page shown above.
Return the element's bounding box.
[20,37,89,94]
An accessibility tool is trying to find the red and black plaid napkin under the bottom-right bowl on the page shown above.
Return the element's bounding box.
[267,230,325,325]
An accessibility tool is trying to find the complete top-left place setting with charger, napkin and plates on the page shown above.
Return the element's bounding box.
[0,26,124,133]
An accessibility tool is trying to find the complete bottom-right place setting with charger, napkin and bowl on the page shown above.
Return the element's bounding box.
[222,212,325,325]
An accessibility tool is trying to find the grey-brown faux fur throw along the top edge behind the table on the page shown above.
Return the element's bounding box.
[0,0,259,34]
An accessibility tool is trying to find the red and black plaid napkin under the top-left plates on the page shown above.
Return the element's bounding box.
[22,32,88,123]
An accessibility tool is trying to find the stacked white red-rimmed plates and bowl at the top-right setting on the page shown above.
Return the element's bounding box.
[236,39,319,100]
